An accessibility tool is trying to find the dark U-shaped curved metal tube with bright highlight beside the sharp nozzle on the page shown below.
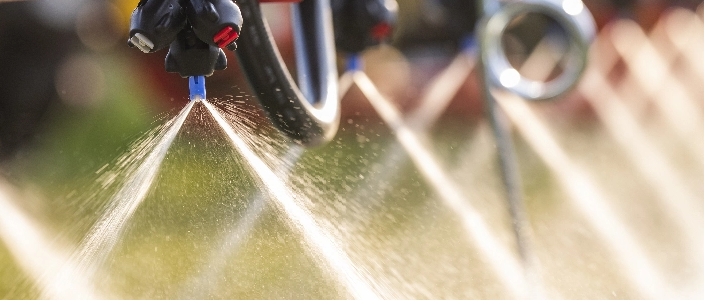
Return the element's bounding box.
[236,0,340,147]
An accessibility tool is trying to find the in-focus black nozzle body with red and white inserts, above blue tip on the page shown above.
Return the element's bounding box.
[128,0,243,77]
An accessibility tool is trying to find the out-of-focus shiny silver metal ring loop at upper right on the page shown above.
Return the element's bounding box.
[478,0,595,100]
